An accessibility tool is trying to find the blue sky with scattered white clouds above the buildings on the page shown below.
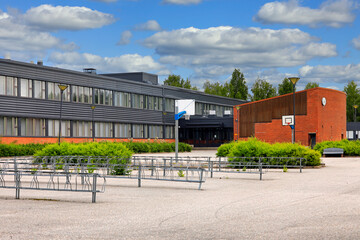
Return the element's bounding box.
[0,0,360,90]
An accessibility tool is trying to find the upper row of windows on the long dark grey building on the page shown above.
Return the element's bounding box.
[0,76,232,117]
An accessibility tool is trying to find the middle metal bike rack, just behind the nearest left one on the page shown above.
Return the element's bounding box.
[33,156,205,189]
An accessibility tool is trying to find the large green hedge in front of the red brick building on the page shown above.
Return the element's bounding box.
[217,138,321,166]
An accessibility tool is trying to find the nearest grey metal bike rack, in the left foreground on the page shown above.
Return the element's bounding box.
[0,158,106,203]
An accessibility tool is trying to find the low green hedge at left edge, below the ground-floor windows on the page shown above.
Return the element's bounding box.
[0,143,47,157]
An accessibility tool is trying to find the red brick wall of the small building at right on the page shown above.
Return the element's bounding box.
[234,88,346,145]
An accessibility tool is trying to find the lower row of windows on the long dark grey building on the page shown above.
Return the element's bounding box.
[0,117,174,138]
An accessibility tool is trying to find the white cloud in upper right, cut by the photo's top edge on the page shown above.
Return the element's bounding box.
[254,0,355,28]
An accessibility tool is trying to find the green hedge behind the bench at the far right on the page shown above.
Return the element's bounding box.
[314,139,360,156]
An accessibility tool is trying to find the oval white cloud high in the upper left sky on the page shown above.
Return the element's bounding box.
[23,4,115,31]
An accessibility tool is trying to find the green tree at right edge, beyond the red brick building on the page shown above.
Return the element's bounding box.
[344,80,360,122]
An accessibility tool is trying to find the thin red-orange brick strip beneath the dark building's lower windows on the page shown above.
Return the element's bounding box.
[0,137,175,144]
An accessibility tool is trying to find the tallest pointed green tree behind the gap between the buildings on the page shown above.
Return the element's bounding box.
[229,69,248,100]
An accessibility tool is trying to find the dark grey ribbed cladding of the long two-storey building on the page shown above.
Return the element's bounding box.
[0,59,244,141]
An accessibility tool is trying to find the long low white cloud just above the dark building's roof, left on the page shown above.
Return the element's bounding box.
[49,52,166,72]
